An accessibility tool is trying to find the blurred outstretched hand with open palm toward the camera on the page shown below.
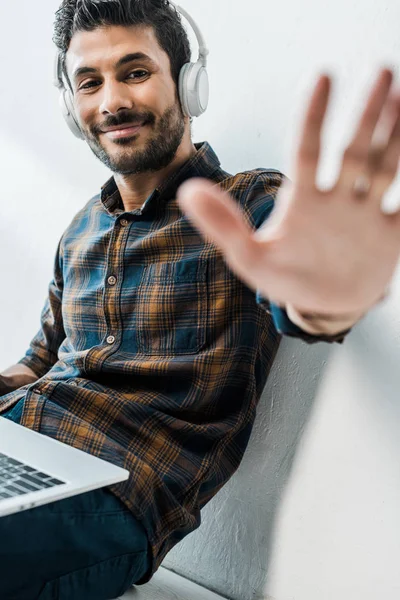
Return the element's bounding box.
[178,69,400,315]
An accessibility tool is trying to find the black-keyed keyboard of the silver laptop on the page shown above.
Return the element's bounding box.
[0,452,67,501]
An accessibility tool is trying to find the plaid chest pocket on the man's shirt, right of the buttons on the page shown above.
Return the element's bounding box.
[136,257,208,356]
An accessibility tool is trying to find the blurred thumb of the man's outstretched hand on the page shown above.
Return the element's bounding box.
[177,179,256,271]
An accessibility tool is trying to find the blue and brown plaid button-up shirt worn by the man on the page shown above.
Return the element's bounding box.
[0,143,348,583]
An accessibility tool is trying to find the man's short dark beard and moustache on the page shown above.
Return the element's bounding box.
[85,102,185,175]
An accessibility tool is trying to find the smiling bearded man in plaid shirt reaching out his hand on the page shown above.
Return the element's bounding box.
[0,0,400,600]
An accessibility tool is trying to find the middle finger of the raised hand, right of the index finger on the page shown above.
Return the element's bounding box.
[336,69,393,194]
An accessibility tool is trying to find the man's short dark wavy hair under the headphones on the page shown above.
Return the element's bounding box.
[53,0,191,90]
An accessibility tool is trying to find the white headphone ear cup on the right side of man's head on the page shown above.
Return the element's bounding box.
[179,62,209,117]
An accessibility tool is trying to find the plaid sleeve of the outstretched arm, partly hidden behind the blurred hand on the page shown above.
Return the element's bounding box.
[246,169,351,344]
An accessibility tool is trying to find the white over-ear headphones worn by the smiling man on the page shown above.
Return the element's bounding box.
[54,0,209,140]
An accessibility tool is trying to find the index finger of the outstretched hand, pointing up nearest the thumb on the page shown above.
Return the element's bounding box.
[294,75,331,189]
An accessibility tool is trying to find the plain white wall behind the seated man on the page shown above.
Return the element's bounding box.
[0,0,400,600]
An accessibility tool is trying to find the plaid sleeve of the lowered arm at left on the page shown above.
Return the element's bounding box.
[18,237,66,378]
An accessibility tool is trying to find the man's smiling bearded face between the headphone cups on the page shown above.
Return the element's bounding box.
[66,26,185,175]
